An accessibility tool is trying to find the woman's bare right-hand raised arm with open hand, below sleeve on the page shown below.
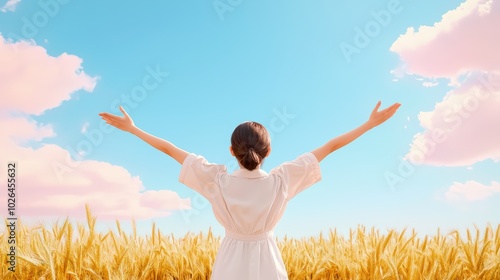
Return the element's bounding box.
[312,101,401,161]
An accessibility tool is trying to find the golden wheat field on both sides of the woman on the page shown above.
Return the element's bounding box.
[0,208,500,280]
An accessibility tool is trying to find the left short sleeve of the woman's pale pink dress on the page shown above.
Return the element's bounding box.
[179,154,226,200]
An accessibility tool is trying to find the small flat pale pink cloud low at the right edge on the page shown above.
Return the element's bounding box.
[444,181,500,201]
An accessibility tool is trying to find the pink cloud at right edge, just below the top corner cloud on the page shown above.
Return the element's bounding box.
[406,75,500,166]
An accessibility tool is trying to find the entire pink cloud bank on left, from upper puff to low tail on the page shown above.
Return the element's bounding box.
[0,36,191,219]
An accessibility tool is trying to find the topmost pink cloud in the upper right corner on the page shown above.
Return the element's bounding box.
[391,0,500,78]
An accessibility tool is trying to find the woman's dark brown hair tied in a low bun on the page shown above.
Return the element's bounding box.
[231,122,271,171]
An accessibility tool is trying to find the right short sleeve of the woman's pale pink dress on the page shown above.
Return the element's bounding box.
[270,153,321,200]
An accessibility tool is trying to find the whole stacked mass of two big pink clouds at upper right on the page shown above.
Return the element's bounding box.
[391,0,500,166]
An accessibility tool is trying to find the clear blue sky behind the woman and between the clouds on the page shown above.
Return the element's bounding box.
[0,0,500,237]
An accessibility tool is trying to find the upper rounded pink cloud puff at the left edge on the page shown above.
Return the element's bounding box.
[0,34,97,115]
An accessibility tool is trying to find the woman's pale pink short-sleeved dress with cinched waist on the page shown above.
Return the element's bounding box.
[179,153,321,280]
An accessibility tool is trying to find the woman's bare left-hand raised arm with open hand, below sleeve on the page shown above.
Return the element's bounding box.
[99,106,189,164]
